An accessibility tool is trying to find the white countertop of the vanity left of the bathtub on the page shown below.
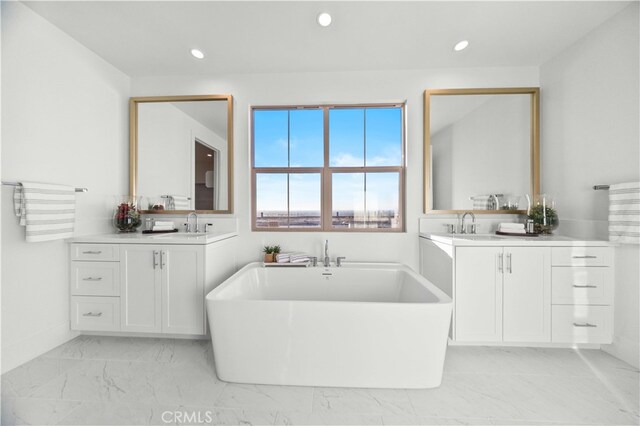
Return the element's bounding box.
[69,231,238,244]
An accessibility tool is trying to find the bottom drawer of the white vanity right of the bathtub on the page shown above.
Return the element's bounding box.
[551,305,613,343]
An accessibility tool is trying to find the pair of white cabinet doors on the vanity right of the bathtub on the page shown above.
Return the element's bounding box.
[454,247,551,342]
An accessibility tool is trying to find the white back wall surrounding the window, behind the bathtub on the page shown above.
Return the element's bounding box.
[132,67,539,270]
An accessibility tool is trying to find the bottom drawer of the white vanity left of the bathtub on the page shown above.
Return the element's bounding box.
[71,296,120,331]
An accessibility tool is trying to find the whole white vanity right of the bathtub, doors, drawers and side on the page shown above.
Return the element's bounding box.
[420,234,614,345]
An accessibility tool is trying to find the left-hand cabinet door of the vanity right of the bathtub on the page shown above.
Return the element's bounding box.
[454,247,502,342]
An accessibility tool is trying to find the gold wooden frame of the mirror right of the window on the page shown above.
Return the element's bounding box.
[423,87,540,214]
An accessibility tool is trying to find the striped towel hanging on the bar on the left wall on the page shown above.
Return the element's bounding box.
[13,182,76,243]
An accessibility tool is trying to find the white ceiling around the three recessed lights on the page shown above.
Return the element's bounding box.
[24,1,631,77]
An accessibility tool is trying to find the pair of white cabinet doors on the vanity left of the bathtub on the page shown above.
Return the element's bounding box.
[120,244,204,334]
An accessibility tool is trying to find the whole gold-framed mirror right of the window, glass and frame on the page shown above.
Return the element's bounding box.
[424,87,540,214]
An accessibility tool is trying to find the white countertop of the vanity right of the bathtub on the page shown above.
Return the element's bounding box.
[420,232,612,247]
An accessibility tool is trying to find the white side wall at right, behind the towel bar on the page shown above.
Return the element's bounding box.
[540,3,640,367]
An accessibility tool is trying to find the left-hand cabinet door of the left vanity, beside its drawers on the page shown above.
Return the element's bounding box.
[120,244,161,333]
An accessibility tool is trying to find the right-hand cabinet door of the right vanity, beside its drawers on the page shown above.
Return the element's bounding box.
[503,247,551,342]
